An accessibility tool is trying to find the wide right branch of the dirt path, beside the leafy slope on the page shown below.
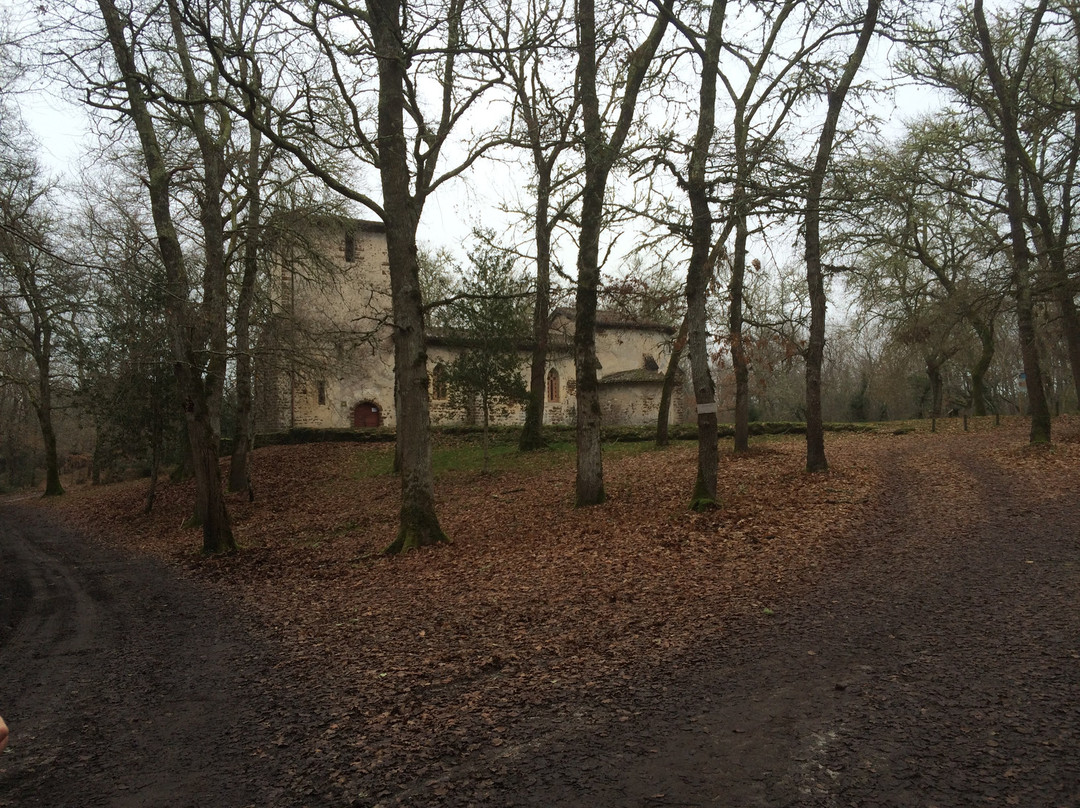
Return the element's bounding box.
[429,439,1080,808]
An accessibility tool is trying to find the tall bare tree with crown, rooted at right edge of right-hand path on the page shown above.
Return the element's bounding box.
[904,2,1080,443]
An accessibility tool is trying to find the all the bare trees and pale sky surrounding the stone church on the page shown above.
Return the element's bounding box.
[0,0,1080,552]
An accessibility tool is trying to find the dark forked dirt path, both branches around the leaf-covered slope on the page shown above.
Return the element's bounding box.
[0,436,1080,808]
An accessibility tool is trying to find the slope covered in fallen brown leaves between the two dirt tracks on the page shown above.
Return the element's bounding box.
[50,418,1080,798]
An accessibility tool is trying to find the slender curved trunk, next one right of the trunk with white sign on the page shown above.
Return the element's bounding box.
[805,0,881,472]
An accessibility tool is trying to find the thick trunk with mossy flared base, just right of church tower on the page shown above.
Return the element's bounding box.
[367,0,446,553]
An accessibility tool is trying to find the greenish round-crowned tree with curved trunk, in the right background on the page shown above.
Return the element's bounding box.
[839,118,1008,415]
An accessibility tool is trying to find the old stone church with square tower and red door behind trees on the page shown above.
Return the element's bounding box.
[255,214,685,433]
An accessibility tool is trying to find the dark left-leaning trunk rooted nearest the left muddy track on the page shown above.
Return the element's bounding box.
[98,0,237,553]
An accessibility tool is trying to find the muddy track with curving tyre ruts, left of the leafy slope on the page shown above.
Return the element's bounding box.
[0,508,324,808]
